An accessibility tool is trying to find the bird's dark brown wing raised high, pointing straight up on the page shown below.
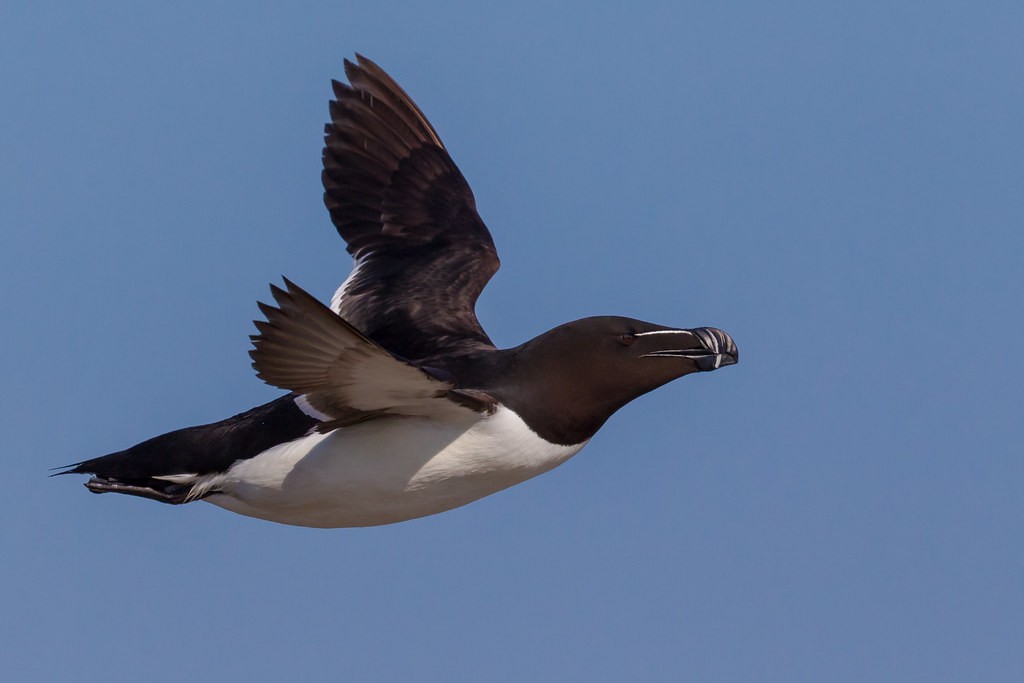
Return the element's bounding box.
[323,55,499,359]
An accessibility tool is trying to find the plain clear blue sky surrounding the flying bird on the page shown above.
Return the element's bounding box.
[0,2,1024,682]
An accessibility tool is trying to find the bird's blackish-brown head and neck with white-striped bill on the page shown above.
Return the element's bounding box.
[494,316,739,444]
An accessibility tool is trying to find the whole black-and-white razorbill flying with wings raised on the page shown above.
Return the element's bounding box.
[57,53,738,528]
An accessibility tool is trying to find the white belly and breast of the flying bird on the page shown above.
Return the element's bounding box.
[199,408,586,527]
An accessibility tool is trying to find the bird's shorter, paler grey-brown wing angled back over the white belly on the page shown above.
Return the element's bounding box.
[249,280,493,430]
